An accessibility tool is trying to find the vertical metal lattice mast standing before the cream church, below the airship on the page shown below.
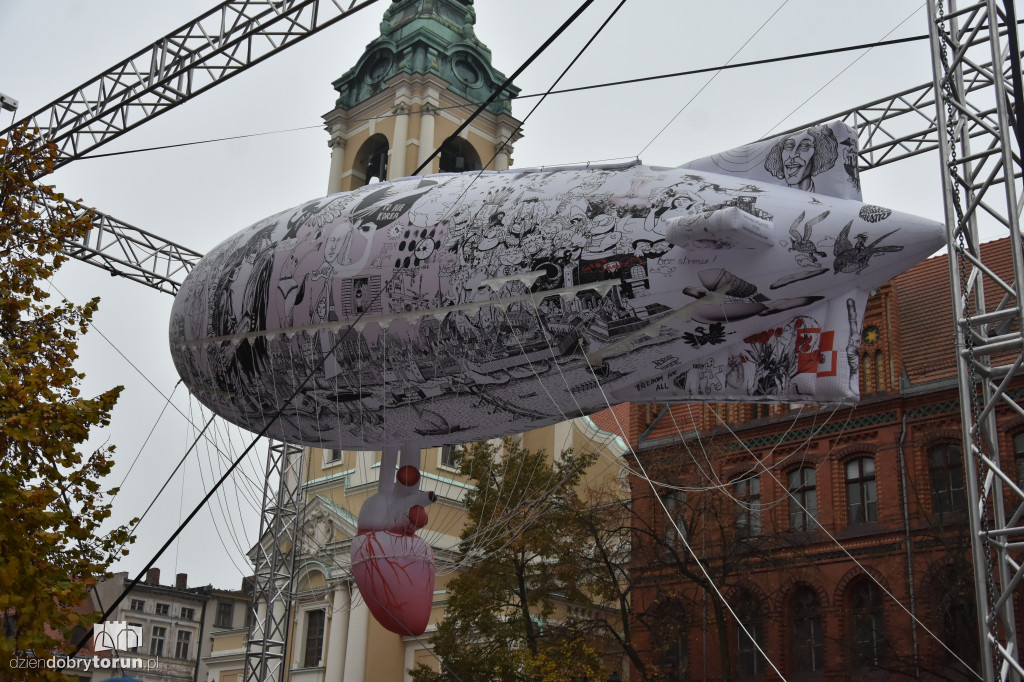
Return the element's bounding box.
[243,442,304,682]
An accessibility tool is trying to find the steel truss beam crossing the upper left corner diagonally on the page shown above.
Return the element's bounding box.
[4,0,378,170]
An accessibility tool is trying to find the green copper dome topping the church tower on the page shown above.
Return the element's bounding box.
[333,0,519,115]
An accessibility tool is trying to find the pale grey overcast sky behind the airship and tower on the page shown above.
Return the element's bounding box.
[0,0,942,588]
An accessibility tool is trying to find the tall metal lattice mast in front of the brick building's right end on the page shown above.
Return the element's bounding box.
[928,0,1024,682]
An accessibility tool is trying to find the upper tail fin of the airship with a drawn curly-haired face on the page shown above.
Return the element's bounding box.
[680,121,861,201]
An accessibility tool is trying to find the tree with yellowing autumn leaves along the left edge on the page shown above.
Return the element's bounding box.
[0,129,129,680]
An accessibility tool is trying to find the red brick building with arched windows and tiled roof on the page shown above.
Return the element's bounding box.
[620,237,1024,680]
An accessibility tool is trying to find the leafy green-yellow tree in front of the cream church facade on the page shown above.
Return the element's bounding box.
[413,439,600,682]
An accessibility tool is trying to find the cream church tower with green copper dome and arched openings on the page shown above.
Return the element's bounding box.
[324,0,519,194]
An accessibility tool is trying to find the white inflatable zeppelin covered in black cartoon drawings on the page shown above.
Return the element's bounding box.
[170,123,944,450]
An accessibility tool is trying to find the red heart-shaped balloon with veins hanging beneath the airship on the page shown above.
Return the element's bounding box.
[352,530,434,636]
